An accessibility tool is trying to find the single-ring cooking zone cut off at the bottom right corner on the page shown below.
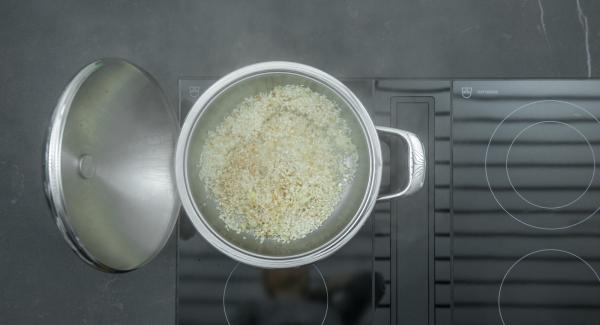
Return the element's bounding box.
[497,248,600,325]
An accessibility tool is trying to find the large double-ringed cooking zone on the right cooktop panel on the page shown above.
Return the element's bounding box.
[485,100,600,230]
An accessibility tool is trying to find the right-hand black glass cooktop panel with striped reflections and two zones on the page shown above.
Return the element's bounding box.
[448,81,600,325]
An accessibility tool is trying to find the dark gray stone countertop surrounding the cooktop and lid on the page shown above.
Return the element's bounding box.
[0,0,600,325]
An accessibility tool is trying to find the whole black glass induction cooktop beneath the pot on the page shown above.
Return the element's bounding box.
[177,78,600,325]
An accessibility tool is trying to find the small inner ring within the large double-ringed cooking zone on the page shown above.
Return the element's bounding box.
[505,121,596,210]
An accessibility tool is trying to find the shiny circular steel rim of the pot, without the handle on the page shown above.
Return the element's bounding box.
[175,61,382,268]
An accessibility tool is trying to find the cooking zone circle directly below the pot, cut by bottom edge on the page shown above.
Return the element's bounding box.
[223,263,329,325]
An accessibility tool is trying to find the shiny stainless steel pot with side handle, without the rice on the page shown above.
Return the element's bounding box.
[175,62,425,268]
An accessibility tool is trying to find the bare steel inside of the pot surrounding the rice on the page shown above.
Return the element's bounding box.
[185,72,379,258]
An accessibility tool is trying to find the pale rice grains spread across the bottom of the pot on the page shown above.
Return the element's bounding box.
[199,85,358,243]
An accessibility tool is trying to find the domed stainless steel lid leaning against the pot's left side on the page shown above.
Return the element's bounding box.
[45,59,180,272]
